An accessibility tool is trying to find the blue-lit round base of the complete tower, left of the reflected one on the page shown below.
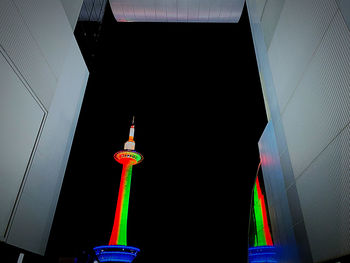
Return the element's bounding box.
[94,245,140,262]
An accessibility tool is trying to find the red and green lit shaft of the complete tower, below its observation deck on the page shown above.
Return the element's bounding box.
[109,162,133,246]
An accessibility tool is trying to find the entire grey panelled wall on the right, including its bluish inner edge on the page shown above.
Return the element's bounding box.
[246,0,350,262]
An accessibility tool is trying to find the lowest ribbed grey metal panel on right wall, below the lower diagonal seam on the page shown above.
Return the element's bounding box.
[297,122,350,262]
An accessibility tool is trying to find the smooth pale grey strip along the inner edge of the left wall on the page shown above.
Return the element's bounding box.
[7,38,88,254]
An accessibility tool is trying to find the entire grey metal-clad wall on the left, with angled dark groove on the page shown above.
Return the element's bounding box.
[0,0,89,254]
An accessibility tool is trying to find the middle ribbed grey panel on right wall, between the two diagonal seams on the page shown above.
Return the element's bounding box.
[282,12,350,177]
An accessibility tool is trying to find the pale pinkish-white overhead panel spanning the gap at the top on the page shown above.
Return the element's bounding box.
[109,0,244,23]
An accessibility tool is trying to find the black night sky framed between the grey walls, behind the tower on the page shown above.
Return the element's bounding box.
[47,3,266,263]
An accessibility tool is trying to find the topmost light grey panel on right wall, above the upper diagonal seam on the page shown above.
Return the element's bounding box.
[268,0,337,112]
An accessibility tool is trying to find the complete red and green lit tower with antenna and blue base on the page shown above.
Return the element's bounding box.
[94,119,143,262]
